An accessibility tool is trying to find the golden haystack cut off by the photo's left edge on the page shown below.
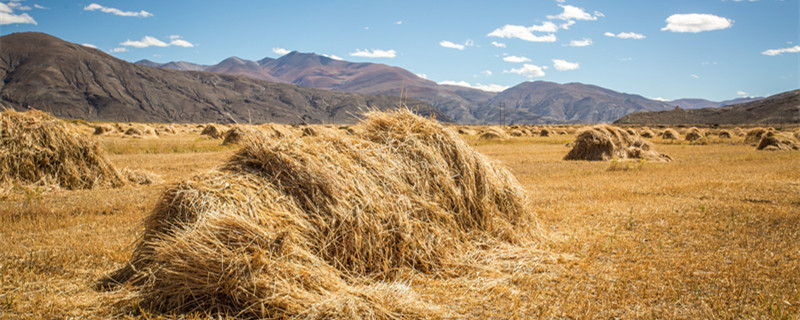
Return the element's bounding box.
[0,110,125,190]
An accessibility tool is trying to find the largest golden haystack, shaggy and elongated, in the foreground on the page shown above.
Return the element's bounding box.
[100,110,537,319]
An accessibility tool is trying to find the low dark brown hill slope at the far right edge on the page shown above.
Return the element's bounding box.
[614,90,800,125]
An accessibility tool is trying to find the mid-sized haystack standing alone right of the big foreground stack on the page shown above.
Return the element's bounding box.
[564,125,672,161]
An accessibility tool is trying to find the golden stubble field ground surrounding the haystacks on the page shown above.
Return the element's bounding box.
[0,129,800,319]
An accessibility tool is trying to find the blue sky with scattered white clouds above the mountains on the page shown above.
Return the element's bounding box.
[0,0,800,101]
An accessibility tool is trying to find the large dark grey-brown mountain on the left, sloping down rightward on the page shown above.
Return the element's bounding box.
[0,33,449,123]
